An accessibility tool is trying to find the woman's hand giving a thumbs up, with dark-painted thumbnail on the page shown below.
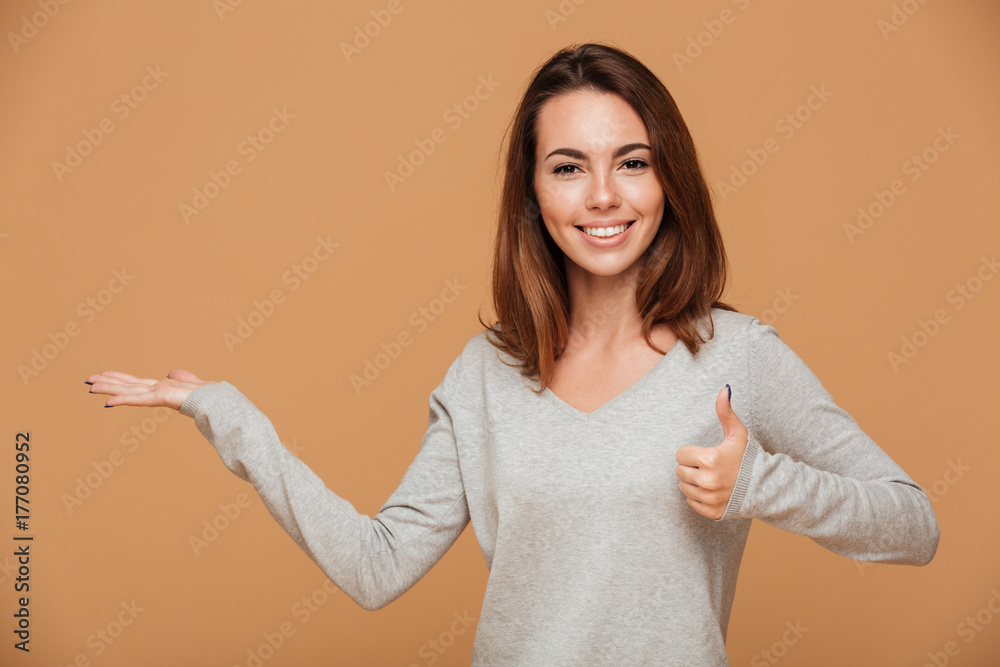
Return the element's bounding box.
[675,385,749,519]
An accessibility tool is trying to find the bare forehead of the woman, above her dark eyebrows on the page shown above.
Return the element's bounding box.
[536,90,649,153]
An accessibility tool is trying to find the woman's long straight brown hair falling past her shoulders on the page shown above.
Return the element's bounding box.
[479,44,736,392]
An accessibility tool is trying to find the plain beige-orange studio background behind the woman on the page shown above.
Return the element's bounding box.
[0,0,1000,667]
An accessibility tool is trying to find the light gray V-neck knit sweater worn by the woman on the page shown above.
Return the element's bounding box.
[180,309,939,667]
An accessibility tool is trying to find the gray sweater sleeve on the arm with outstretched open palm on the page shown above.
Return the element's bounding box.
[180,364,469,610]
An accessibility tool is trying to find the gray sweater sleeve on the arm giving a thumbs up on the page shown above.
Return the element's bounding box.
[720,318,940,565]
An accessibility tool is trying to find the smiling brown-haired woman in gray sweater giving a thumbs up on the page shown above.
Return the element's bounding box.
[87,44,939,665]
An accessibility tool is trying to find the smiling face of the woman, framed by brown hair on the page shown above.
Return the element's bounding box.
[534,90,665,276]
